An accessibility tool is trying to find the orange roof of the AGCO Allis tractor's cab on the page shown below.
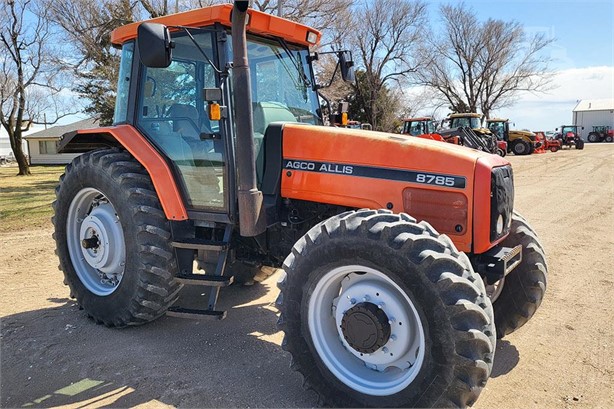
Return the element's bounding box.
[111,4,322,46]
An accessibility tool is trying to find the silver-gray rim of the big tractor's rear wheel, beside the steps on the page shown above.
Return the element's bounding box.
[66,188,126,297]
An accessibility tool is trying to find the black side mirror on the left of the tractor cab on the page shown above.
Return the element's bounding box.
[136,23,173,68]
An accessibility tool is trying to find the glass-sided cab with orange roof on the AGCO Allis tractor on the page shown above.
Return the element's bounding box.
[104,5,352,213]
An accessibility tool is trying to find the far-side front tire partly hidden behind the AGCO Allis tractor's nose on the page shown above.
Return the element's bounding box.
[487,213,548,338]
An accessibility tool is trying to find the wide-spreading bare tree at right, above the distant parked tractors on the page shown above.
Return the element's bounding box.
[415,3,553,116]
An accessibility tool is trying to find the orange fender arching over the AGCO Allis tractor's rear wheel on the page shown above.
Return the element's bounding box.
[58,125,188,220]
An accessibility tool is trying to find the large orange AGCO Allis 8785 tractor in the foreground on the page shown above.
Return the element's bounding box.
[53,1,547,407]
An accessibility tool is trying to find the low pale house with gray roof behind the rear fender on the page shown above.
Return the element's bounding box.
[24,118,99,165]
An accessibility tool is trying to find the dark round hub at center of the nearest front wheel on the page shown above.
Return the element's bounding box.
[341,302,390,354]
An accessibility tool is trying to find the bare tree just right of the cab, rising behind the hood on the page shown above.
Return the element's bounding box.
[349,0,426,130]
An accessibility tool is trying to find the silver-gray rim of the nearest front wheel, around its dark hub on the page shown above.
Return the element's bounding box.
[308,265,426,396]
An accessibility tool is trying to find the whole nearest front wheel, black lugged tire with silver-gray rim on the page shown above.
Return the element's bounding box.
[278,210,496,407]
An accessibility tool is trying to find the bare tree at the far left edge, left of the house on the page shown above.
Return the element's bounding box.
[0,0,75,175]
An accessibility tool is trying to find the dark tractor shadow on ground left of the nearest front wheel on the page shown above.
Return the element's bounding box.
[0,279,315,408]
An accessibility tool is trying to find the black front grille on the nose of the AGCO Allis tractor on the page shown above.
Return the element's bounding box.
[490,165,514,242]
